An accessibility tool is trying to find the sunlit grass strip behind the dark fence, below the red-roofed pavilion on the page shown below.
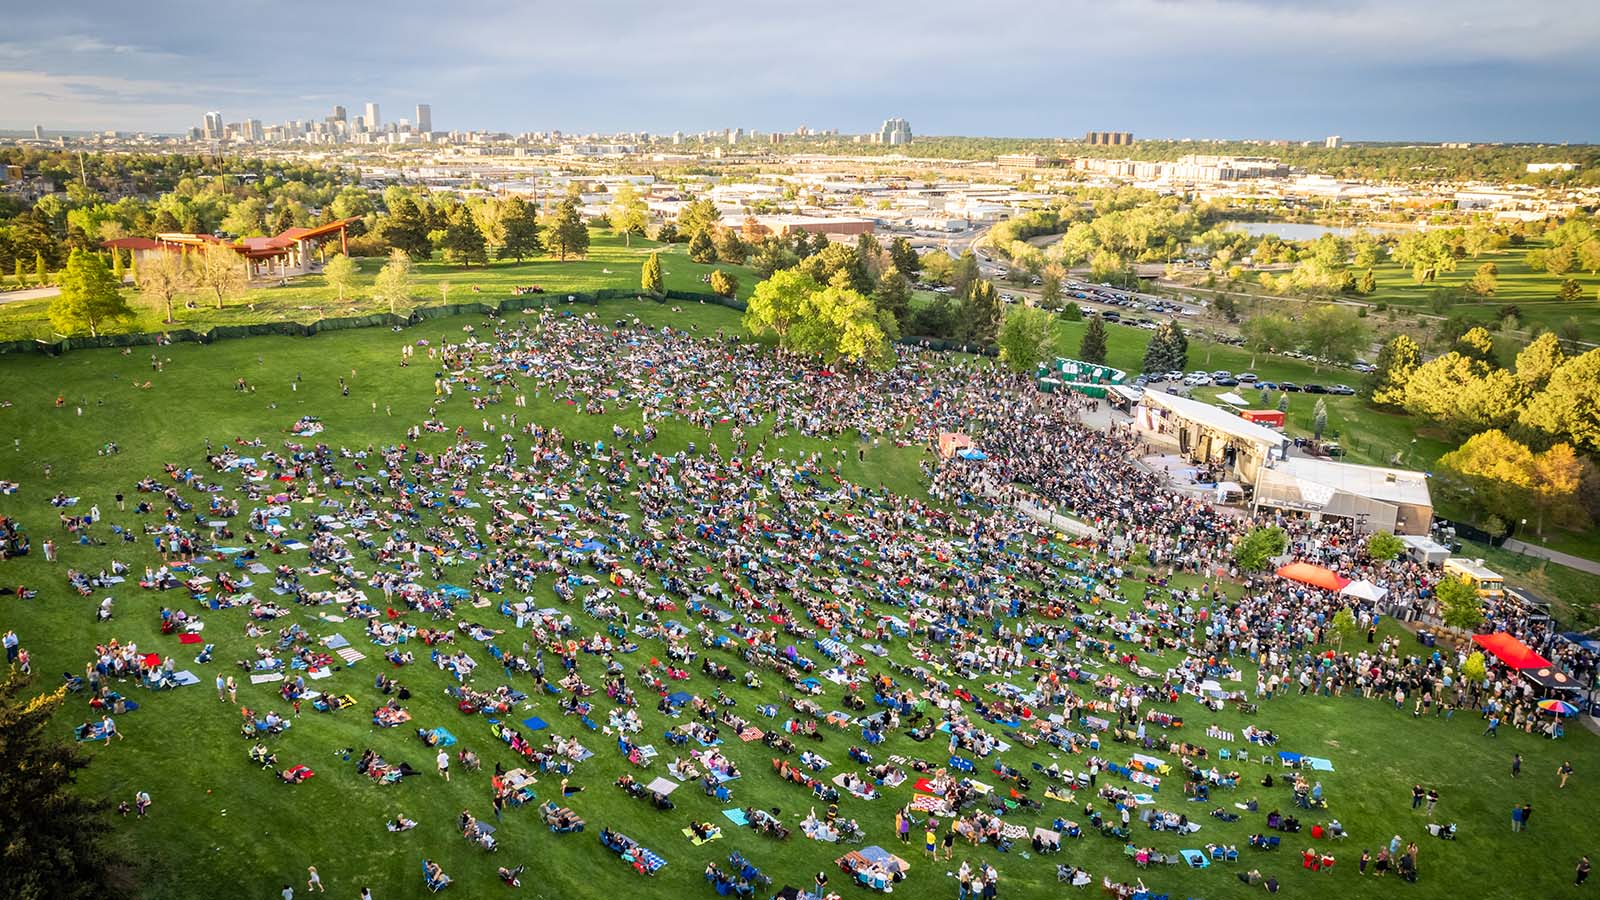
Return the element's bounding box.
[0,229,757,340]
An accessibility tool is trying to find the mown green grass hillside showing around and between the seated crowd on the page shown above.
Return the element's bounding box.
[0,299,1600,900]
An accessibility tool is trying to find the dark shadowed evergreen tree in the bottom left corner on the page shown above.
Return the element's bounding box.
[0,666,124,900]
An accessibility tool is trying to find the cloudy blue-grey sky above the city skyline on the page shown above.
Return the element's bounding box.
[0,0,1600,143]
